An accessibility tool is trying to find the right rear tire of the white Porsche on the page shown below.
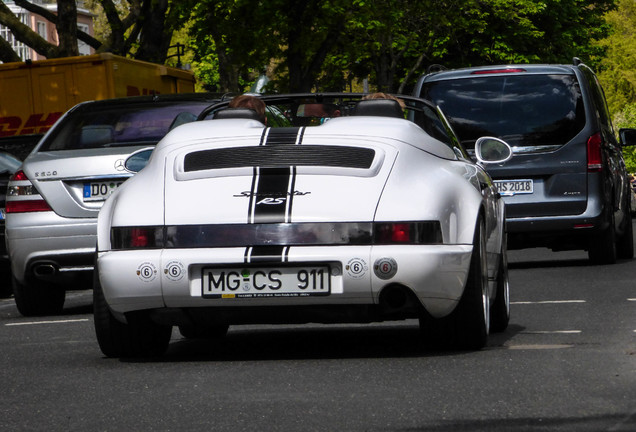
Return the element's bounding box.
[420,220,490,350]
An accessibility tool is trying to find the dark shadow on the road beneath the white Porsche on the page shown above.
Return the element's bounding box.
[122,321,524,362]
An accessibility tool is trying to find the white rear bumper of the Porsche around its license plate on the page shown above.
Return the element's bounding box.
[98,245,472,324]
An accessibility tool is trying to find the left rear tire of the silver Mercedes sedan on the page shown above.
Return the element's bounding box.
[12,277,66,316]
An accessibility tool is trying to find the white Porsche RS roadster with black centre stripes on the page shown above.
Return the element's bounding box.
[93,94,511,357]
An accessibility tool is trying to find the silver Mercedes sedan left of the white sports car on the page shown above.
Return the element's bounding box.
[6,93,218,316]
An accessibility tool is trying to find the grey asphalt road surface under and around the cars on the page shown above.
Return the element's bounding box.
[0,238,636,432]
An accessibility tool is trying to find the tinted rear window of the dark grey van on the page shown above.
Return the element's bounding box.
[421,75,585,149]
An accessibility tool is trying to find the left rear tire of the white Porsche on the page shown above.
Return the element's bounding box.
[93,267,172,357]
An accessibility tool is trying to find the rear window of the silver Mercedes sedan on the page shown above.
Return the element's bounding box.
[39,101,210,151]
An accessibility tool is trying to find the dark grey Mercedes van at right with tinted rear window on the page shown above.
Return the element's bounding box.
[415,59,634,264]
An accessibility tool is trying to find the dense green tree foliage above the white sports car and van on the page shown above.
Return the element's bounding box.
[185,0,614,92]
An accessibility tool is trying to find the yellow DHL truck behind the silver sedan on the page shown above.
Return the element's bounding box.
[0,53,195,156]
